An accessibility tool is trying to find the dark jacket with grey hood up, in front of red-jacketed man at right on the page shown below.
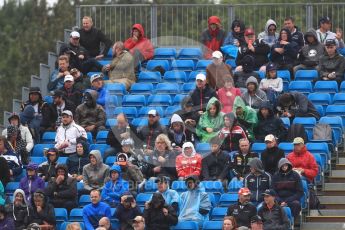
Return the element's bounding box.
[272,158,303,203]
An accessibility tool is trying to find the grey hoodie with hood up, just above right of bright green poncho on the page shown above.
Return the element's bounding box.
[241,76,268,111]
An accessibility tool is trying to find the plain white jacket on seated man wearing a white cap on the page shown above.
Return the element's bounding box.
[55,121,87,154]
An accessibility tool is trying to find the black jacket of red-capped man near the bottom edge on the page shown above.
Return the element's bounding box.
[226,202,257,228]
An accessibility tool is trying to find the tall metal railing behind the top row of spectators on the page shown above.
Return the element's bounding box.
[76,3,345,46]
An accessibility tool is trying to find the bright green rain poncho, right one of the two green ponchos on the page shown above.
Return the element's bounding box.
[232,97,258,140]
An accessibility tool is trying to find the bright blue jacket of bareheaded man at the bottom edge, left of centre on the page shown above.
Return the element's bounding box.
[83,202,111,230]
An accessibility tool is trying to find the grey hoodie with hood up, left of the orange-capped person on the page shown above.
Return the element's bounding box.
[83,150,110,190]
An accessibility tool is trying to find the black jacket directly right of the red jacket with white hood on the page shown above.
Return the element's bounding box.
[201,150,230,181]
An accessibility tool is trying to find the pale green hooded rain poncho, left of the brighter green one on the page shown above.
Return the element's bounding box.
[196,97,224,142]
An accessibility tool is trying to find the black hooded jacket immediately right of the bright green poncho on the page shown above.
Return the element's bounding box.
[254,102,287,142]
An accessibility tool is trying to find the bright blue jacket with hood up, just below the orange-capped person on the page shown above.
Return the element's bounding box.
[102,165,129,204]
